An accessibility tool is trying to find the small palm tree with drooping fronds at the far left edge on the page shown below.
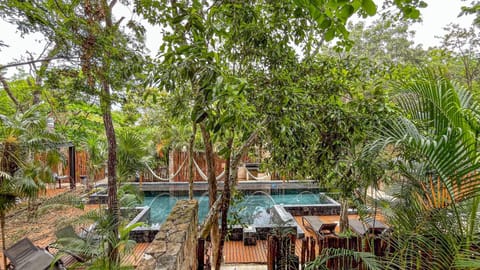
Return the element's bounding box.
[0,106,61,266]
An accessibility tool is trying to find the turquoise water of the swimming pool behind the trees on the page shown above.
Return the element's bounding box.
[144,191,331,225]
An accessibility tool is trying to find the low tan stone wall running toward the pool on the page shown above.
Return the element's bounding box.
[137,200,198,270]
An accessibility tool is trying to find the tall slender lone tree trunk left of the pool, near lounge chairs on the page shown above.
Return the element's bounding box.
[100,80,120,264]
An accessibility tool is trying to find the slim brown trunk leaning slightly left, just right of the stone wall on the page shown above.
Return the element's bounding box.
[200,123,221,270]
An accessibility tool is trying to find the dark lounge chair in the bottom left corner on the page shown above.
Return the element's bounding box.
[3,238,65,270]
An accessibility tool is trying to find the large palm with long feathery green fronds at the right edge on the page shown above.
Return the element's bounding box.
[369,72,480,269]
